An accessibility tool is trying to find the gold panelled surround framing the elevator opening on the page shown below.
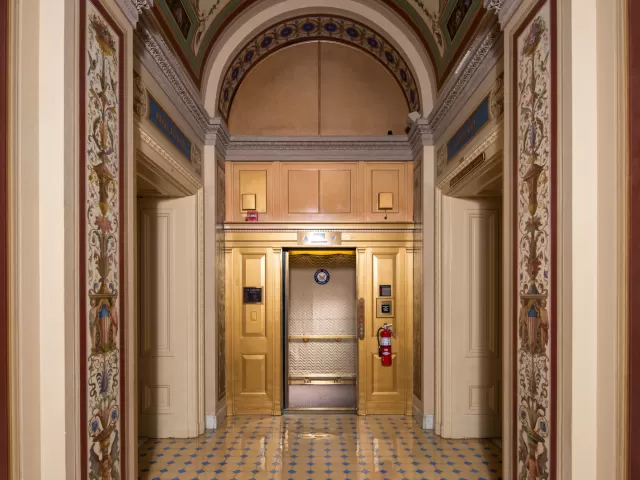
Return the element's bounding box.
[224,223,421,415]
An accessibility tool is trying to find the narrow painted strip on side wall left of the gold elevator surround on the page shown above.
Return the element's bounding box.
[216,163,227,401]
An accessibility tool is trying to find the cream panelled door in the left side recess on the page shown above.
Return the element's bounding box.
[138,196,198,438]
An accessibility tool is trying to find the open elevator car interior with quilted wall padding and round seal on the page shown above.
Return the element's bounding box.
[285,250,357,411]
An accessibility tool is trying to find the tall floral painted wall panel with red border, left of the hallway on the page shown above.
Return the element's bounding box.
[80,0,125,480]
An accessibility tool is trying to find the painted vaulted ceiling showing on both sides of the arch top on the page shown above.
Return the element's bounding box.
[154,0,485,88]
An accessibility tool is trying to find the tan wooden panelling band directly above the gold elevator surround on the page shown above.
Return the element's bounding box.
[226,162,414,223]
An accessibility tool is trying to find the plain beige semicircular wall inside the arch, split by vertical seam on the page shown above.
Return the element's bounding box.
[229,42,409,136]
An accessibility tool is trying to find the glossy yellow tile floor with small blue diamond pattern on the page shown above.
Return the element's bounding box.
[139,415,502,480]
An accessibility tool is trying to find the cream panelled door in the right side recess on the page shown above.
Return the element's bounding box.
[443,197,501,438]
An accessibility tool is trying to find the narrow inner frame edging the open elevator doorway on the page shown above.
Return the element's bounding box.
[281,247,366,414]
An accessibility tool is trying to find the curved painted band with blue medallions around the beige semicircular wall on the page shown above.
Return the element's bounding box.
[218,15,420,119]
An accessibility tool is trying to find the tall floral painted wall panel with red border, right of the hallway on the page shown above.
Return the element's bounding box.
[513,0,557,480]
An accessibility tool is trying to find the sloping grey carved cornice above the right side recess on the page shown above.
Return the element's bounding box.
[428,19,502,141]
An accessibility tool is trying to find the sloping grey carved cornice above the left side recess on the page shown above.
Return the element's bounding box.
[136,18,211,140]
